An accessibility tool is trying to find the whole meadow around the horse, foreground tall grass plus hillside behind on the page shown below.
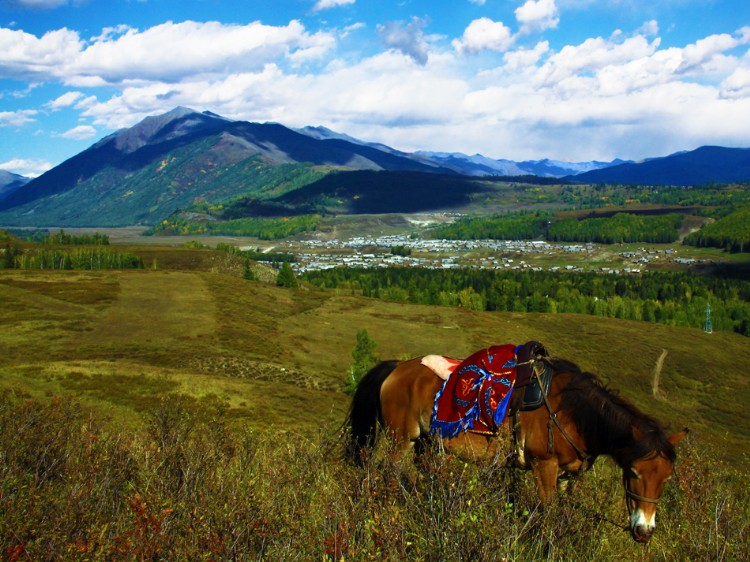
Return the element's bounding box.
[0,245,750,560]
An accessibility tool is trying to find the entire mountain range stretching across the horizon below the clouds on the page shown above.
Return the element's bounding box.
[0,107,750,226]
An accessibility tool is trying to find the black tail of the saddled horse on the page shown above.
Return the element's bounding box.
[346,360,399,465]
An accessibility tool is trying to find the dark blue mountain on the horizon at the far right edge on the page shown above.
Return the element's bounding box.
[568,146,750,185]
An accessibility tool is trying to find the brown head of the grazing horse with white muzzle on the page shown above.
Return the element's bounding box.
[622,430,687,543]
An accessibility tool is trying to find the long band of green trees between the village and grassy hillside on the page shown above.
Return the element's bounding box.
[302,268,750,336]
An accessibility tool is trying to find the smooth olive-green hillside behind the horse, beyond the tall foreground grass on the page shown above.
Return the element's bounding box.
[0,254,750,468]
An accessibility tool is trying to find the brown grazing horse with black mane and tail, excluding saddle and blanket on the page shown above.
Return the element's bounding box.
[347,352,687,542]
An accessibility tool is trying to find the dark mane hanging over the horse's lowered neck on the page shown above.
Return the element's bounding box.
[550,358,676,467]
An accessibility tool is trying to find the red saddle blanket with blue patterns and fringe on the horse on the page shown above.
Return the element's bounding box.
[430,344,518,438]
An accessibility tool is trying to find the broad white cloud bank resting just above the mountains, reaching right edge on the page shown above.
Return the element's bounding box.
[54,21,750,159]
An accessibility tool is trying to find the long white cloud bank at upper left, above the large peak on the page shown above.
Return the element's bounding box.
[0,20,335,87]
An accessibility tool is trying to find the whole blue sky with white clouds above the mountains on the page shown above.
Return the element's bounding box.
[0,0,750,176]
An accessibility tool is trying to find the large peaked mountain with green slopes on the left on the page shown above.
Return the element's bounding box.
[0,107,454,226]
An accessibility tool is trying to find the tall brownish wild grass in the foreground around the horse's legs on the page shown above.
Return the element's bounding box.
[0,391,750,560]
